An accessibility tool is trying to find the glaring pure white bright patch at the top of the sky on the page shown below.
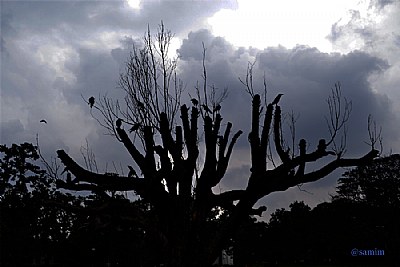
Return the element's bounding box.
[208,0,366,52]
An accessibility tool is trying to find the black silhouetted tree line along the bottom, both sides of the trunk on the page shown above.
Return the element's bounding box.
[0,143,400,266]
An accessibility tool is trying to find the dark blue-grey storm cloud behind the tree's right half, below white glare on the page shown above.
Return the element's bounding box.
[179,30,400,216]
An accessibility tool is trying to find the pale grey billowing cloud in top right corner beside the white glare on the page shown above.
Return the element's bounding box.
[329,1,400,112]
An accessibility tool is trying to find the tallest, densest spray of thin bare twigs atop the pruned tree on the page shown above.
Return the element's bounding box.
[91,22,184,143]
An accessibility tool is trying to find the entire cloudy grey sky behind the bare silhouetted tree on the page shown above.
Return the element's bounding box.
[0,0,400,218]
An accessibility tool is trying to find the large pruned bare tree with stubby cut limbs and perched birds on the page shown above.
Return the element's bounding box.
[57,25,378,266]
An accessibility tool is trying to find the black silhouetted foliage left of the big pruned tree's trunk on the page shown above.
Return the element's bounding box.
[0,143,160,266]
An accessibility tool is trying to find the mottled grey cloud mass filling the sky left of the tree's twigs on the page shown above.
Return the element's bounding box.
[1,1,236,166]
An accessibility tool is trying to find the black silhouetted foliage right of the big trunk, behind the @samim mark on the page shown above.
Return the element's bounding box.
[234,157,400,266]
